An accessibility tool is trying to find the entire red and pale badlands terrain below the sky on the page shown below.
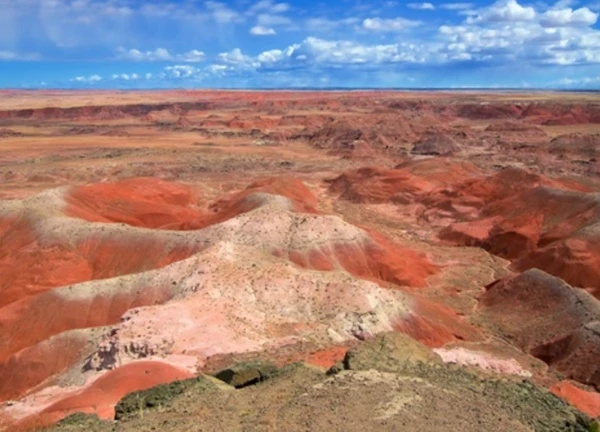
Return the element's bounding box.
[0,91,600,431]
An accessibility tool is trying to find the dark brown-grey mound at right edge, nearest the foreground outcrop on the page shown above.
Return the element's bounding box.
[481,269,600,389]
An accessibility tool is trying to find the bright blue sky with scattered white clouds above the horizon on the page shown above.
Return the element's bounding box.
[0,0,600,89]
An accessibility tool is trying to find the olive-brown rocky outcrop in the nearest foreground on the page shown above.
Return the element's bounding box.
[45,334,595,432]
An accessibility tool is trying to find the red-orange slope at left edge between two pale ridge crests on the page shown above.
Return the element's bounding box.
[0,219,194,308]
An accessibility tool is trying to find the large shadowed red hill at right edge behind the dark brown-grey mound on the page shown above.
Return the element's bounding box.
[440,182,600,289]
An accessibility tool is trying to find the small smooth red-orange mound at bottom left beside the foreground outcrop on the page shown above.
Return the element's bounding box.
[22,361,193,427]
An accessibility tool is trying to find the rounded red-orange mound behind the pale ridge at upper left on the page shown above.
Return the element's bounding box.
[65,178,205,228]
